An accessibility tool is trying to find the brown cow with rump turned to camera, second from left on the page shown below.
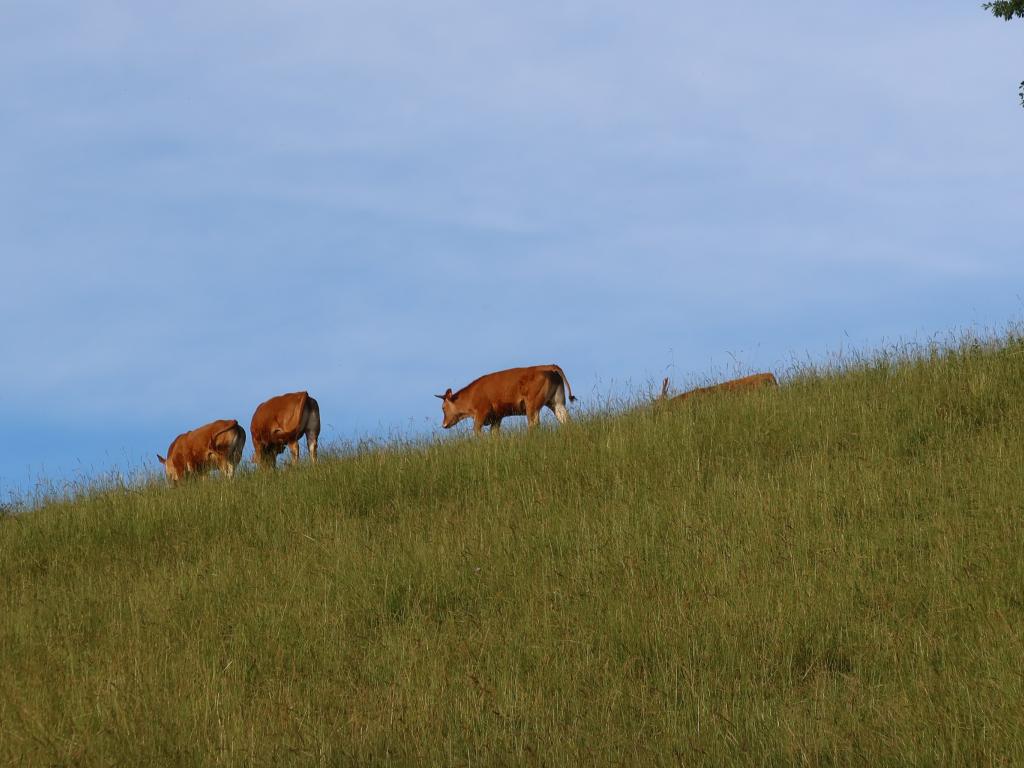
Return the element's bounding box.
[249,392,319,468]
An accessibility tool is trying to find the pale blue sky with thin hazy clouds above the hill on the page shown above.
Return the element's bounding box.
[0,0,1024,498]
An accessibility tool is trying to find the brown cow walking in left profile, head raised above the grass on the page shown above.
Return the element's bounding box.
[434,366,575,433]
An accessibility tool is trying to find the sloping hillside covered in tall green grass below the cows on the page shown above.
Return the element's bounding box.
[0,338,1024,765]
